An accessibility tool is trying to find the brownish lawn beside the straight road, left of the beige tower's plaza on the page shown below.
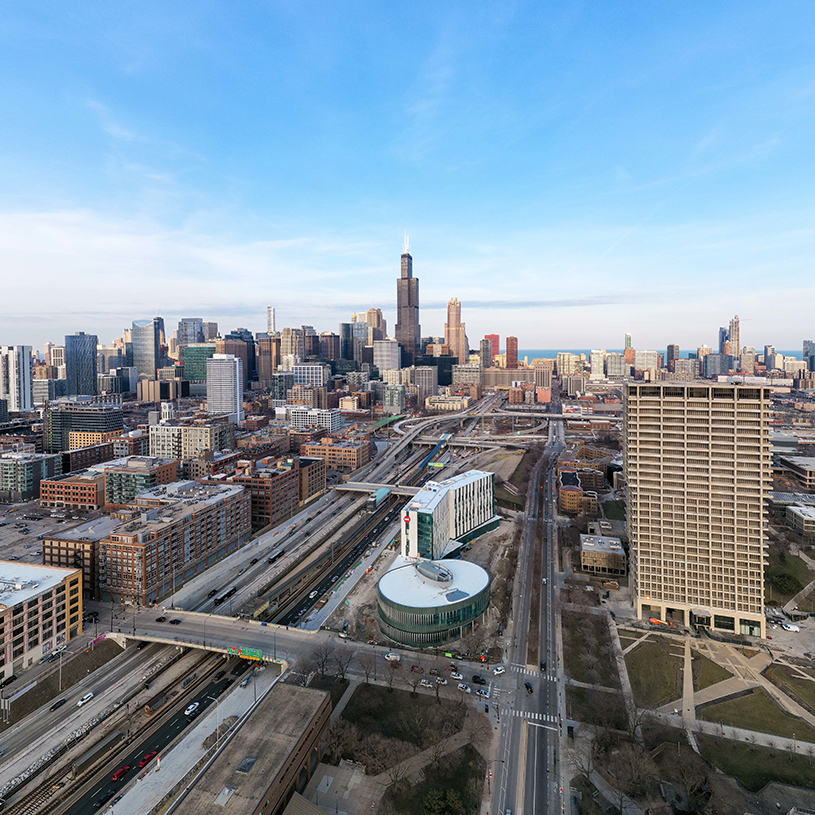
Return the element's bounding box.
[561,611,620,688]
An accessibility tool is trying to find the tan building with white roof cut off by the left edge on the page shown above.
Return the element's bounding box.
[0,560,82,679]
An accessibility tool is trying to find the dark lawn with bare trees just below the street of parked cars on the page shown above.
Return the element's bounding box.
[342,684,466,744]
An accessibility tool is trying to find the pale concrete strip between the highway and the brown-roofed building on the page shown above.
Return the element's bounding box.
[107,669,282,815]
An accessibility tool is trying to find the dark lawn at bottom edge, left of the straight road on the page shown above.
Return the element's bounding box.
[385,745,485,815]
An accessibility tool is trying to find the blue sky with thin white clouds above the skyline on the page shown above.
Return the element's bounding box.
[0,0,815,348]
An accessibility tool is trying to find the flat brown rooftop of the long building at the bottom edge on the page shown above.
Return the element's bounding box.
[177,682,328,815]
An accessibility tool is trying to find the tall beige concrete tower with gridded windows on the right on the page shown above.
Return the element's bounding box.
[624,382,772,636]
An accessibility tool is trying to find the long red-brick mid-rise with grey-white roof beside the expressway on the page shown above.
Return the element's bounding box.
[98,481,251,606]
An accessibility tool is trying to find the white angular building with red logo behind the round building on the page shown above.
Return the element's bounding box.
[401,470,499,560]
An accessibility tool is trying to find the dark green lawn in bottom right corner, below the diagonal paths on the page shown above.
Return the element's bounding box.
[696,735,815,792]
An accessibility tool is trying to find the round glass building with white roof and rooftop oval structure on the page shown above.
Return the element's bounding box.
[377,558,490,647]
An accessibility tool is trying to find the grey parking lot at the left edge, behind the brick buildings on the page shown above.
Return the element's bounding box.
[0,501,99,563]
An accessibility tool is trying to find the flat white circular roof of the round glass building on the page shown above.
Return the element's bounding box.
[379,555,490,608]
